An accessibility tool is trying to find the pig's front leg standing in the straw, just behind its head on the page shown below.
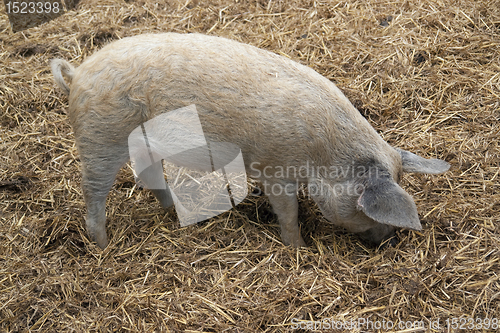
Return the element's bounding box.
[266,184,306,248]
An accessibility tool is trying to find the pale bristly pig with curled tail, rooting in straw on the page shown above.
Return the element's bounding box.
[51,33,449,249]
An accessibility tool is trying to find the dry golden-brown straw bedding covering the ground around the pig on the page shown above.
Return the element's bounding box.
[0,0,500,332]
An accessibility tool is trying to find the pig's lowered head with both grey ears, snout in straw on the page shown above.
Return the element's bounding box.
[311,149,450,244]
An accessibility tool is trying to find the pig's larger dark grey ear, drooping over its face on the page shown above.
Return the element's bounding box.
[358,174,422,230]
